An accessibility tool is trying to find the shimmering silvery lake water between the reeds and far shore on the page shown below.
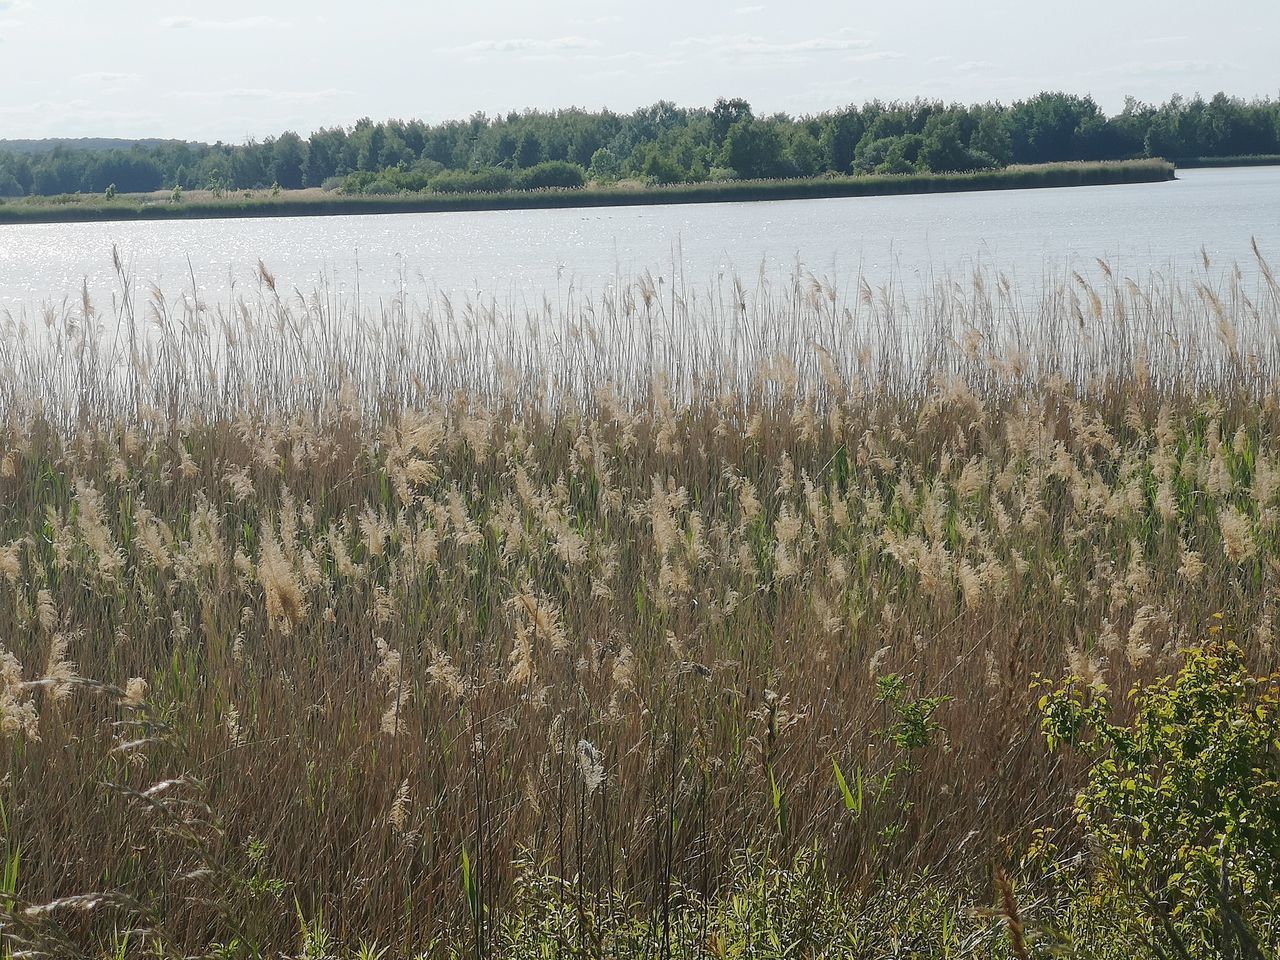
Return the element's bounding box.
[0,168,1280,315]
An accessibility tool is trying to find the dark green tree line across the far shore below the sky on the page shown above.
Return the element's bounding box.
[0,92,1280,197]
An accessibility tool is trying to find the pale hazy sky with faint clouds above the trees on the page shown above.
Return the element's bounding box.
[0,0,1280,142]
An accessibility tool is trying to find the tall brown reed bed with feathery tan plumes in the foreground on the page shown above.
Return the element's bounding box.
[0,244,1280,957]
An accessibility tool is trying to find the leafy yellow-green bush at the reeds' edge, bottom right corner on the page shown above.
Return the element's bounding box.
[1039,640,1280,957]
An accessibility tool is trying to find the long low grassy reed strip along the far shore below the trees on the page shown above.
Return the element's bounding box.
[0,160,1175,224]
